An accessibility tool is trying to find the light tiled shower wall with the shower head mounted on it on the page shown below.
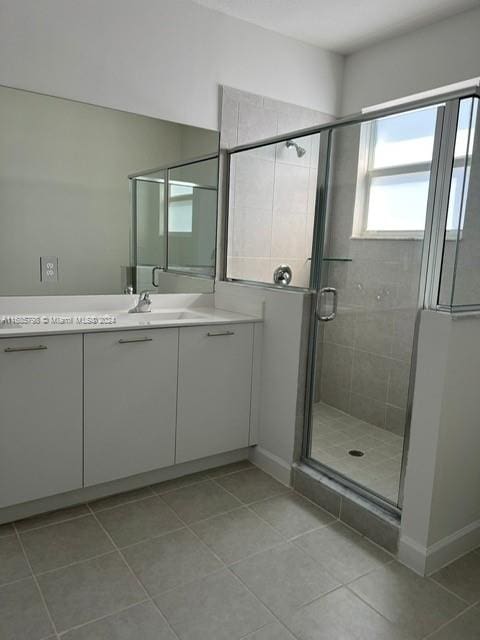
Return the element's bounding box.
[220,87,332,287]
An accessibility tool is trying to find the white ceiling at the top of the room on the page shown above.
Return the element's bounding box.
[189,0,480,54]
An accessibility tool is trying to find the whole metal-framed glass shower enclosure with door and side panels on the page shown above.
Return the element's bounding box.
[224,89,480,511]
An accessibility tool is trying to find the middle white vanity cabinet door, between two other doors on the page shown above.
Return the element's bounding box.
[84,329,178,486]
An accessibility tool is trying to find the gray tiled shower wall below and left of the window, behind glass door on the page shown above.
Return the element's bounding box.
[317,126,422,435]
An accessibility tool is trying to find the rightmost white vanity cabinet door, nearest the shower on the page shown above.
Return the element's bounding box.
[175,324,253,462]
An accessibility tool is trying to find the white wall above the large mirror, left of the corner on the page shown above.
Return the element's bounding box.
[0,0,343,129]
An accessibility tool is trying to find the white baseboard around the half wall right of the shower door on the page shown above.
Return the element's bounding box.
[398,520,480,576]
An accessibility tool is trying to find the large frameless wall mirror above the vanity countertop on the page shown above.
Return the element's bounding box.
[0,87,218,296]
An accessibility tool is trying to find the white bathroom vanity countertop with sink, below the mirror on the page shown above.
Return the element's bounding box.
[0,306,263,338]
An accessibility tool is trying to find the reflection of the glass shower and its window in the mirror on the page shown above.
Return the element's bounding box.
[132,155,218,292]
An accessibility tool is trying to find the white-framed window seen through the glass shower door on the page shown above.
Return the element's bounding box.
[353,107,437,238]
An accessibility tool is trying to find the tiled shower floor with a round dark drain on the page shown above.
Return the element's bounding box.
[311,402,403,504]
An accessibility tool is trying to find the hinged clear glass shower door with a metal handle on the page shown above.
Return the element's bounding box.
[307,106,443,505]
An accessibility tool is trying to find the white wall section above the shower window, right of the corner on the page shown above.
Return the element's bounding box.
[341,9,480,115]
